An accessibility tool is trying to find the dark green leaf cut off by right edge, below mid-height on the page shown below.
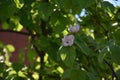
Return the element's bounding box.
[110,45,120,64]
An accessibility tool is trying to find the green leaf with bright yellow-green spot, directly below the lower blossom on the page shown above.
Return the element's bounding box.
[58,47,76,67]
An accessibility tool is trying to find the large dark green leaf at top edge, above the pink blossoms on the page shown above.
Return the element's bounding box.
[59,0,95,14]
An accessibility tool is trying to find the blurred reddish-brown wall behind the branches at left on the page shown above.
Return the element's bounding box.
[0,22,28,63]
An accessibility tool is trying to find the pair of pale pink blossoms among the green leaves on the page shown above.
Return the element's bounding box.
[62,24,80,46]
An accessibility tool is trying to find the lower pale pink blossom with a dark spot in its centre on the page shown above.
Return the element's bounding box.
[62,35,74,46]
